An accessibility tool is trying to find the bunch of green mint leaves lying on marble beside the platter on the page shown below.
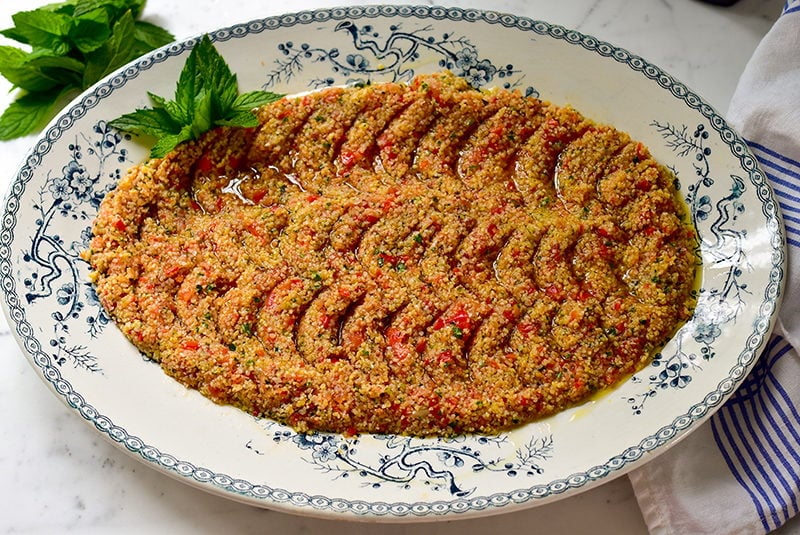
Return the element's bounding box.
[0,0,174,140]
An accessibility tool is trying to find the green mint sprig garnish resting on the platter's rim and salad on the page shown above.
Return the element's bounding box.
[109,35,283,158]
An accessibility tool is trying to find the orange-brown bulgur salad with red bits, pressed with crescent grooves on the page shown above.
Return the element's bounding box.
[84,73,697,436]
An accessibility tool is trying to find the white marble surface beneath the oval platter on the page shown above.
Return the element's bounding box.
[0,0,783,535]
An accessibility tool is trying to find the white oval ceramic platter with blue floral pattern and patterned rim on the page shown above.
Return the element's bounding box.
[0,6,785,521]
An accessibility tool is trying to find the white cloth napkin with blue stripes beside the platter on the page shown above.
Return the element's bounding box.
[629,0,800,535]
